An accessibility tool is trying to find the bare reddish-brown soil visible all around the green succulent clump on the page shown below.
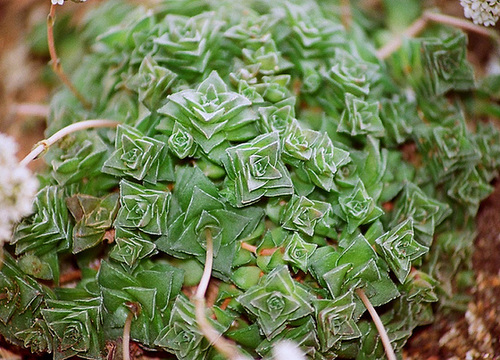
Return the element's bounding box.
[0,0,500,360]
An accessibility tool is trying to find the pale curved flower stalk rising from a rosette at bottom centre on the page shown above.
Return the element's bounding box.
[193,228,245,360]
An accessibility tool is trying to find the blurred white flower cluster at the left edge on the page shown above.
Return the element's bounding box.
[0,133,38,245]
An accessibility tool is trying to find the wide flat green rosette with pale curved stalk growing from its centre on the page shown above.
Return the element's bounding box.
[156,168,262,278]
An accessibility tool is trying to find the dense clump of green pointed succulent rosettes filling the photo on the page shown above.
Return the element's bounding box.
[0,0,500,360]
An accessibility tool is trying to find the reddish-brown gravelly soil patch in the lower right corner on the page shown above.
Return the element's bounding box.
[406,182,500,360]
